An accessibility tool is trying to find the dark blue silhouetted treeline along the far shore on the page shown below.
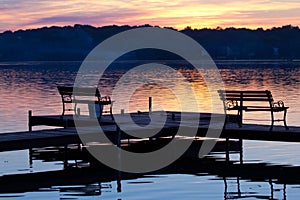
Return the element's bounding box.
[0,25,300,61]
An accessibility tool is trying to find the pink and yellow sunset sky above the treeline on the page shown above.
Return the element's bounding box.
[0,0,300,32]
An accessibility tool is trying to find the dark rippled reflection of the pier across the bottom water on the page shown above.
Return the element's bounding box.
[0,157,300,199]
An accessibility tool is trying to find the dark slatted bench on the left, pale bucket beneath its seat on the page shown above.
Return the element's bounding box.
[57,86,112,118]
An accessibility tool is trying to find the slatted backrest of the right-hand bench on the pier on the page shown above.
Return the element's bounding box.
[218,90,274,104]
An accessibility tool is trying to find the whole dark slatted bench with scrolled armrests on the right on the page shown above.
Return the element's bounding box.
[218,90,289,130]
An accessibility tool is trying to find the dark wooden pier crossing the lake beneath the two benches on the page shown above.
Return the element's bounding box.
[0,112,300,162]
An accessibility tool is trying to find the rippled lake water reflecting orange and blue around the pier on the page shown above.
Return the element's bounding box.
[0,61,300,199]
